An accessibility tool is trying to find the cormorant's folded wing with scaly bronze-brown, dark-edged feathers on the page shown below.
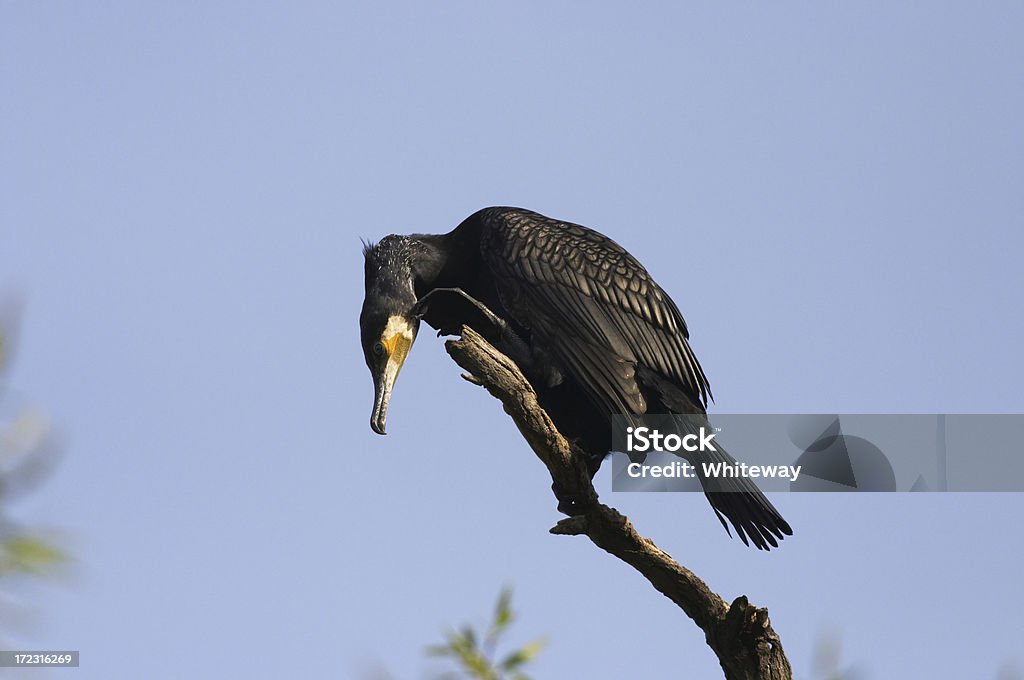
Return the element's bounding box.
[481,208,711,413]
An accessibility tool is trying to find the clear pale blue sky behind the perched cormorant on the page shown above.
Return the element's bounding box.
[0,2,1024,678]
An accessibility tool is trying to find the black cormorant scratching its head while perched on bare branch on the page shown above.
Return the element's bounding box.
[359,208,793,550]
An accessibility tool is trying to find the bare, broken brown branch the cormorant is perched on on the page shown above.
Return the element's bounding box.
[444,327,793,680]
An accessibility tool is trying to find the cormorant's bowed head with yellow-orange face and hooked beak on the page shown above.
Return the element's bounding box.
[359,237,420,434]
